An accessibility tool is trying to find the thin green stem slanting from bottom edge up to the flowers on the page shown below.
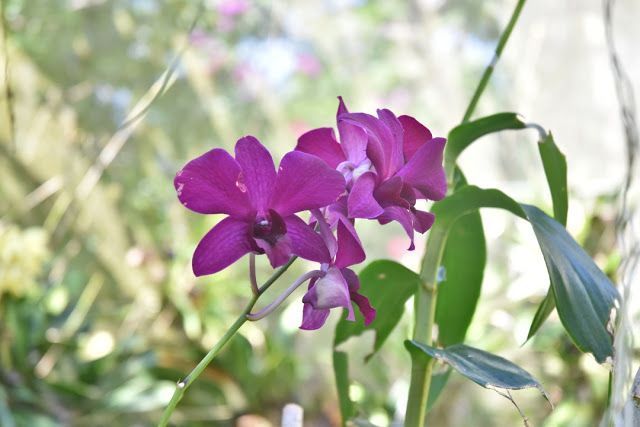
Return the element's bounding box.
[158,257,297,427]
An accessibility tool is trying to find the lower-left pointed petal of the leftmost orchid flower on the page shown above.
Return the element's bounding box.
[192,217,252,276]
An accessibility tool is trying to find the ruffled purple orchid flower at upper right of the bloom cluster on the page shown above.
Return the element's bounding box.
[296,97,447,250]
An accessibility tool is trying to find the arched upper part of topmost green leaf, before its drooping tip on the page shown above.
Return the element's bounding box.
[444,113,525,180]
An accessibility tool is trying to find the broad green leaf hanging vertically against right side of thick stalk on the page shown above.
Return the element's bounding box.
[436,170,487,347]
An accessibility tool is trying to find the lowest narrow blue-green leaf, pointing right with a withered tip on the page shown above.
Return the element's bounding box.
[405,340,548,400]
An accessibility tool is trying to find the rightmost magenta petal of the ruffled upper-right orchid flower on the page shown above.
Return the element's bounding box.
[397,138,447,200]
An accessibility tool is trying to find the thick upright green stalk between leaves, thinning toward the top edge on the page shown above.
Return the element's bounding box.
[405,0,526,427]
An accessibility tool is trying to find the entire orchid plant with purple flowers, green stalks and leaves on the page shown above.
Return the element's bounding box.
[160,1,620,427]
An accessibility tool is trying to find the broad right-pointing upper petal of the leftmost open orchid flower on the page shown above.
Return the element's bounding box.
[271,151,345,217]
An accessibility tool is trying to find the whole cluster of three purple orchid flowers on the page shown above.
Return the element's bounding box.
[174,97,446,330]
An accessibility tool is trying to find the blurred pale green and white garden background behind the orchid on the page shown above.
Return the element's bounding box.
[0,0,640,426]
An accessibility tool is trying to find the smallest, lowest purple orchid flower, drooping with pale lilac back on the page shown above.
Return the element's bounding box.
[300,207,376,330]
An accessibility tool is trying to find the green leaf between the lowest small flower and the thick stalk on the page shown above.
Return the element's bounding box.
[334,260,420,359]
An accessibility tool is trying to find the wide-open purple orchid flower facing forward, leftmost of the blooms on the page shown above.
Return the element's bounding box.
[174,136,345,276]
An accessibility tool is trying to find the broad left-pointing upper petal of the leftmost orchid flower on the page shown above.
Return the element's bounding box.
[173,148,249,217]
